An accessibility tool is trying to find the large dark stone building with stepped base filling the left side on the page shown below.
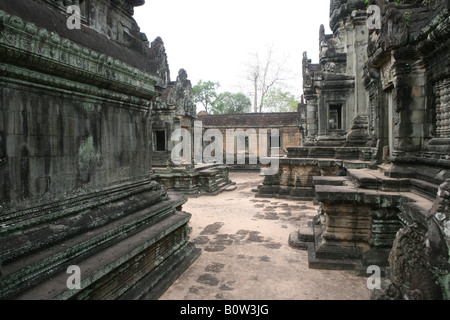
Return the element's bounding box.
[0,0,207,299]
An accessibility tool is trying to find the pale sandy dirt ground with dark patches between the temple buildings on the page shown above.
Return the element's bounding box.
[160,172,371,300]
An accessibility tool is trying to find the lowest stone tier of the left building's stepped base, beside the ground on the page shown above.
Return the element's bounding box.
[15,212,200,300]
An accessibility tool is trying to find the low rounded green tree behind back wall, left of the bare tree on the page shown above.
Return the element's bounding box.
[211,92,252,114]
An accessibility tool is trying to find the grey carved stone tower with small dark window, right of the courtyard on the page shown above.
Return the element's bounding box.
[303,1,370,146]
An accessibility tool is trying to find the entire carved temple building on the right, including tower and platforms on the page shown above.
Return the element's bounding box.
[276,0,450,299]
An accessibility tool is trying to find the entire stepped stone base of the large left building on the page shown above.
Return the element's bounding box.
[0,180,200,300]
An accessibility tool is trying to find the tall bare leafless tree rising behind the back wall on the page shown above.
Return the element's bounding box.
[247,47,287,113]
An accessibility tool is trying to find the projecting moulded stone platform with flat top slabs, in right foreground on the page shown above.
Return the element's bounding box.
[289,168,438,274]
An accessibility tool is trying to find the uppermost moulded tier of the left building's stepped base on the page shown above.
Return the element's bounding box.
[0,181,169,264]
